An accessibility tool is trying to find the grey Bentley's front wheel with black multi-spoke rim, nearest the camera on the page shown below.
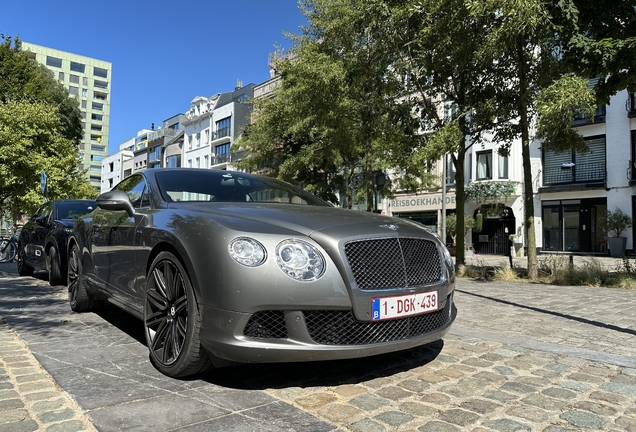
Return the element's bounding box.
[144,252,212,378]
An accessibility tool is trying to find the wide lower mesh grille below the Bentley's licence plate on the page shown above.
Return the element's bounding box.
[303,297,452,345]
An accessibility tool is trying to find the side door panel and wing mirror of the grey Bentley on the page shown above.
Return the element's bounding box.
[92,174,149,305]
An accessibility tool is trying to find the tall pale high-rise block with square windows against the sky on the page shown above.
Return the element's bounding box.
[22,42,112,190]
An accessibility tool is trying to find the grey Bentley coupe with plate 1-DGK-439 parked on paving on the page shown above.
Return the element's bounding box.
[68,168,457,377]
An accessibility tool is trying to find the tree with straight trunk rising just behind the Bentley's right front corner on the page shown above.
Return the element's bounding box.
[380,0,508,264]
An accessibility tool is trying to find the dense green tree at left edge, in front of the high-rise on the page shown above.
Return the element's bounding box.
[0,36,96,220]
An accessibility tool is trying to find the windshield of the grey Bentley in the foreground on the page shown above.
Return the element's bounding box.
[155,168,329,206]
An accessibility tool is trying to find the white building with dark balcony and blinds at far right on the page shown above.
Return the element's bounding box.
[531,91,636,254]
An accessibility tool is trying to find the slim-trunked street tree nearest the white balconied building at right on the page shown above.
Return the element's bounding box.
[471,0,594,278]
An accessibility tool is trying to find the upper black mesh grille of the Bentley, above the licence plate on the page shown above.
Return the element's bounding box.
[345,238,442,290]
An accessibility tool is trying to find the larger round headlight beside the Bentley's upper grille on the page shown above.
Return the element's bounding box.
[276,239,325,281]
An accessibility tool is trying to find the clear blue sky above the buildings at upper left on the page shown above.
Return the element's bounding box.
[0,0,306,153]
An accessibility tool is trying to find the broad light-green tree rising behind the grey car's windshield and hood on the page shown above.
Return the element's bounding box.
[238,0,430,211]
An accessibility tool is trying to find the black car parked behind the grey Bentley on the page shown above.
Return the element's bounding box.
[18,200,97,285]
